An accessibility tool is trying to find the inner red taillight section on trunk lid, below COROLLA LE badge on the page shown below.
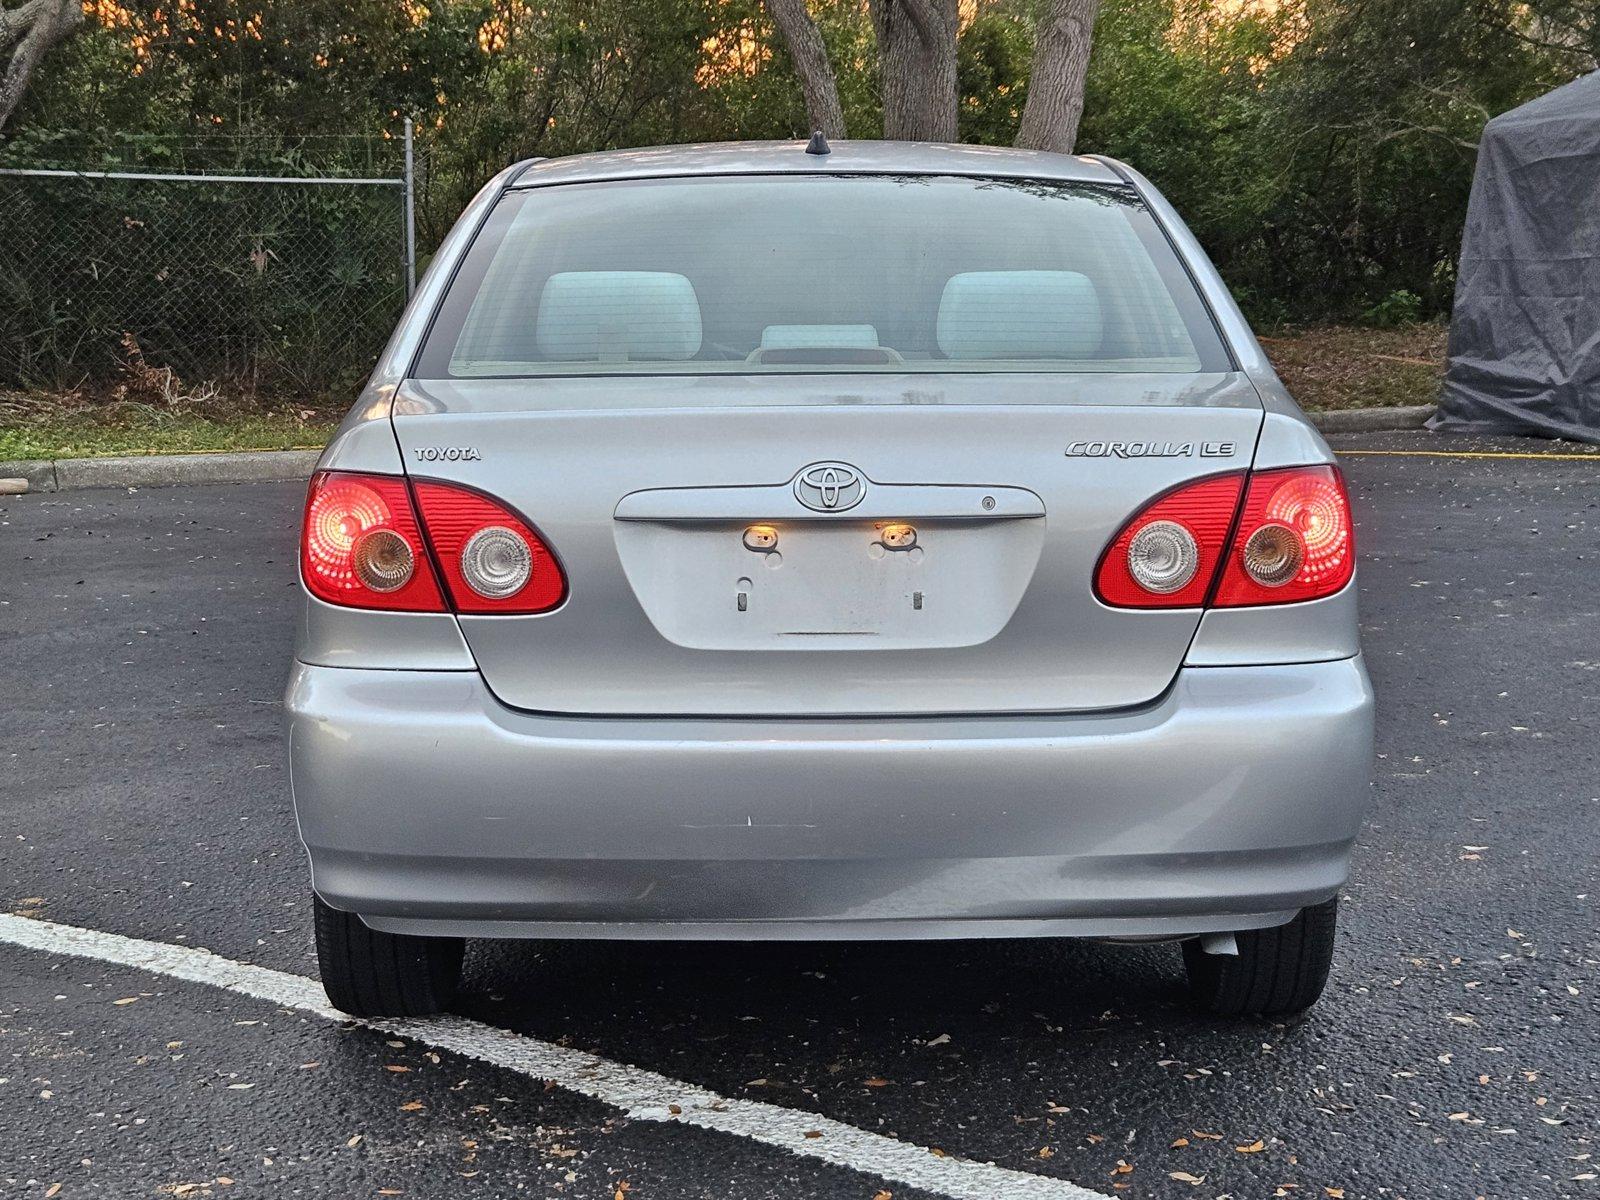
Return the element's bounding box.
[1094,474,1245,608]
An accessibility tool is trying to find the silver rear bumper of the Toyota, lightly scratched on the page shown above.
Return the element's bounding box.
[288,658,1373,938]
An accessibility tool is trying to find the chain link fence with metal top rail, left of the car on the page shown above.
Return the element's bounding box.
[0,131,414,398]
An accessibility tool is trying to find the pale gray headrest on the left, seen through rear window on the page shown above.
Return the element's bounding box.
[534,270,701,363]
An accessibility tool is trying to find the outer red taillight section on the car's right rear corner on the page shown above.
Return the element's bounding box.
[1211,467,1355,608]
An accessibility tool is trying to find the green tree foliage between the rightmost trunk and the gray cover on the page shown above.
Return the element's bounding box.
[1083,0,1548,318]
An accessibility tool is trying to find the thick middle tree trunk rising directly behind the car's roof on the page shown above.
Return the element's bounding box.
[869,0,957,142]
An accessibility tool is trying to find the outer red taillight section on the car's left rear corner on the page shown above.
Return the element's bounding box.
[301,470,445,613]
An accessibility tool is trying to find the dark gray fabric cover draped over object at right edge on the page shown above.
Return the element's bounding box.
[1429,72,1600,442]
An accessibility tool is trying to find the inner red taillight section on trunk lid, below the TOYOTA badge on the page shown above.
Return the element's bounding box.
[414,482,566,613]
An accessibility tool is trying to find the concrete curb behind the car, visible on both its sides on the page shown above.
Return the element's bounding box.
[0,405,1434,491]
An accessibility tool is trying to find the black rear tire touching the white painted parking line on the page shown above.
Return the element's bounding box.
[312,894,466,1016]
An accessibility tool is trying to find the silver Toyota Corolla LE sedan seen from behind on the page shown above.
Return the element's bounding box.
[288,142,1373,1014]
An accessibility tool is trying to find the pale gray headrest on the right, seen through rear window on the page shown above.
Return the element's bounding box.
[934,270,1104,358]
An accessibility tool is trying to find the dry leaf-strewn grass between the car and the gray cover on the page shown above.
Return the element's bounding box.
[1261,322,1450,408]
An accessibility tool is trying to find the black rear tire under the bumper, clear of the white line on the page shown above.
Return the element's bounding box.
[1184,896,1339,1016]
